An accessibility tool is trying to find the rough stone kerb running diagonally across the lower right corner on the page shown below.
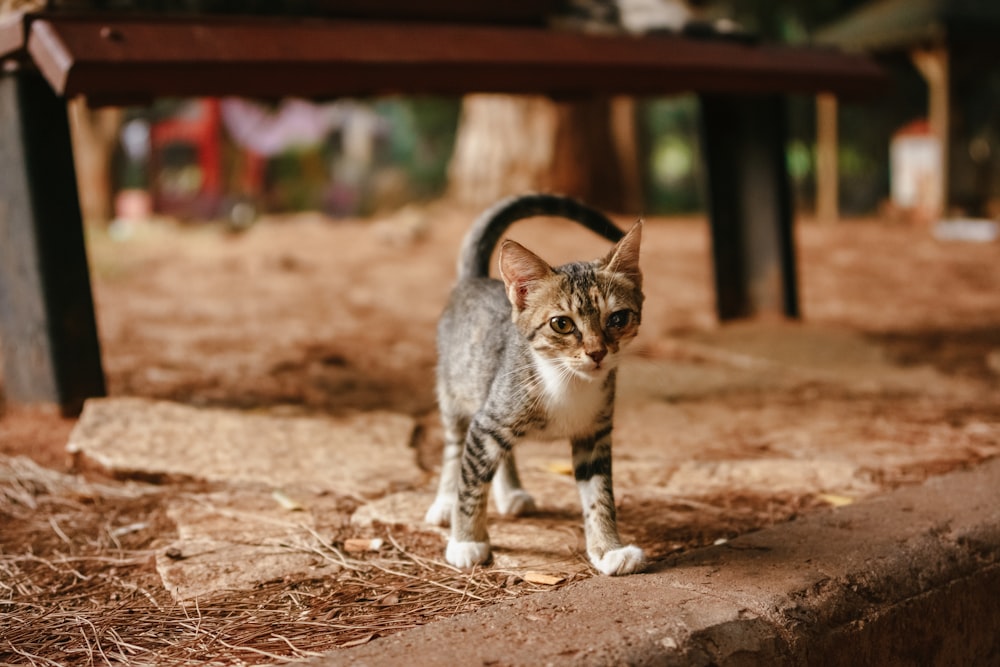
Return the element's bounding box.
[303,460,1000,667]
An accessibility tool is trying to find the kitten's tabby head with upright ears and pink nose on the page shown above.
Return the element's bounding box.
[499,220,643,379]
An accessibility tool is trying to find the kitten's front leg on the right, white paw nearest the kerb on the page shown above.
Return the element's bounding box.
[573,424,646,576]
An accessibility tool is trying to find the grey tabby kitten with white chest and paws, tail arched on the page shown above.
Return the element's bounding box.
[425,194,645,575]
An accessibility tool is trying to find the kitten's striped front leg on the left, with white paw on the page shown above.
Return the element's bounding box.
[445,419,510,569]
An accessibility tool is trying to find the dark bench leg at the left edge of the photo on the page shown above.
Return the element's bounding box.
[0,69,105,415]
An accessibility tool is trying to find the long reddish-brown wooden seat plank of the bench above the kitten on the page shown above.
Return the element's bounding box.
[28,16,883,99]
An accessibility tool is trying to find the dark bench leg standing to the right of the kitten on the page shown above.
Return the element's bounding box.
[701,95,799,320]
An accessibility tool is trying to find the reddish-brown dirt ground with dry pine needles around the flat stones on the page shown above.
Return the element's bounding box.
[0,203,1000,664]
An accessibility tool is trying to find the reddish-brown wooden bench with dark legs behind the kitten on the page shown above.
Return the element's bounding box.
[0,13,884,413]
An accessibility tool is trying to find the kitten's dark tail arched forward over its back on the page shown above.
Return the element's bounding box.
[458,194,625,280]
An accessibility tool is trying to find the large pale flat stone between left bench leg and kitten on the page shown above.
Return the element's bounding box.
[67,398,424,497]
